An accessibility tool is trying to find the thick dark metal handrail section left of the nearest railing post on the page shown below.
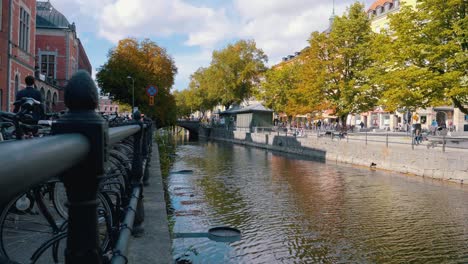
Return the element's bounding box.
[0,134,90,204]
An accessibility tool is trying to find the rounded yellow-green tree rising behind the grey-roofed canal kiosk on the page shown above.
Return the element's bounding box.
[206,40,268,108]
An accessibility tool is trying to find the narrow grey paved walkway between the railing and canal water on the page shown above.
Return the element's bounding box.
[128,143,173,264]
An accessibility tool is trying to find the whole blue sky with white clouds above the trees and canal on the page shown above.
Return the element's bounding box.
[50,0,374,90]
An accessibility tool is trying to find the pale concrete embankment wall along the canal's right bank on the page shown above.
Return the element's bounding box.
[199,128,468,183]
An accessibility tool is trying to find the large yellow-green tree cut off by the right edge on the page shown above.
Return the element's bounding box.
[380,0,468,114]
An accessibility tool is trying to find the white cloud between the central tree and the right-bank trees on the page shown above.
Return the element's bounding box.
[234,0,369,64]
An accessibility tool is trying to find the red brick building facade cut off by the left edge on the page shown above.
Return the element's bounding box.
[0,0,36,111]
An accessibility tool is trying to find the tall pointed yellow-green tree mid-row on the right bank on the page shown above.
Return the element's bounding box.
[302,3,376,123]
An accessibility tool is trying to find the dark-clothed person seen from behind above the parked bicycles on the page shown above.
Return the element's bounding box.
[13,75,44,122]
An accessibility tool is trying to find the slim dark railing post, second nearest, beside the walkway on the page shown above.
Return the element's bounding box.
[132,111,145,236]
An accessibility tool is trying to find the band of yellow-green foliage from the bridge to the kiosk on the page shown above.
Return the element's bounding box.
[175,40,267,116]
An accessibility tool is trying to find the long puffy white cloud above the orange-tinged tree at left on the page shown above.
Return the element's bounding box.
[98,0,230,47]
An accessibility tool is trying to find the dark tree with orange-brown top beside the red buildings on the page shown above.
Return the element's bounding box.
[96,38,177,125]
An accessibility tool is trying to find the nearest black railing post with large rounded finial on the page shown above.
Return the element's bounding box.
[52,71,109,264]
